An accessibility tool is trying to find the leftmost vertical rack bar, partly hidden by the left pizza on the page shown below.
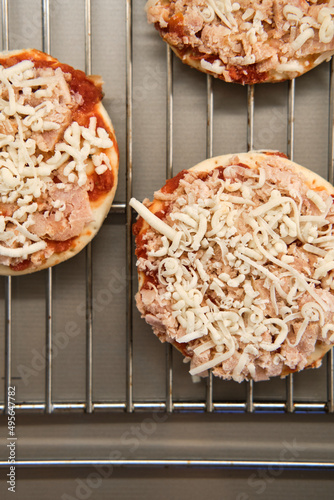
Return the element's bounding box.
[1,0,12,413]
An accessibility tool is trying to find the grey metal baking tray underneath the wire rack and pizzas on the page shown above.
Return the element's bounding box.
[0,0,334,500]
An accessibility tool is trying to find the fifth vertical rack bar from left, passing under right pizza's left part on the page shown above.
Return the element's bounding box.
[166,45,173,413]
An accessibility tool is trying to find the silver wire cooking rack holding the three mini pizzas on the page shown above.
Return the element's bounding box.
[0,0,334,468]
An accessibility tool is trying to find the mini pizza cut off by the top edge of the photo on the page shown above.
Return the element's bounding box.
[146,0,334,84]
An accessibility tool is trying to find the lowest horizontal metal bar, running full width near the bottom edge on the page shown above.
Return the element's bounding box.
[0,459,334,470]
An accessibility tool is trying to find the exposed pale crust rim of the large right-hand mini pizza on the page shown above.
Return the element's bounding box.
[137,150,334,378]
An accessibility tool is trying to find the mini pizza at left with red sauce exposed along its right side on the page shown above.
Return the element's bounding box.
[0,49,118,275]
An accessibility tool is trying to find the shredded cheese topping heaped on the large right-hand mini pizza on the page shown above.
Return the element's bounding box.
[130,160,334,381]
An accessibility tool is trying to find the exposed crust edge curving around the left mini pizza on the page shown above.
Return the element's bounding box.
[0,49,119,276]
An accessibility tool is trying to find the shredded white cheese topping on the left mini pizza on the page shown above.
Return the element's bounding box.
[0,60,113,265]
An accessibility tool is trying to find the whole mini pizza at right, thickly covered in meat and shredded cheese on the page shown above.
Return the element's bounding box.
[130,152,334,382]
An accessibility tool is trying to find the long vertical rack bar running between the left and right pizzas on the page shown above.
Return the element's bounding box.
[126,0,133,413]
